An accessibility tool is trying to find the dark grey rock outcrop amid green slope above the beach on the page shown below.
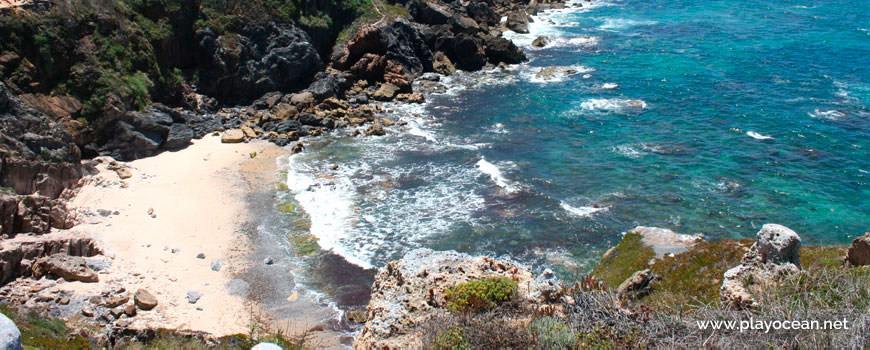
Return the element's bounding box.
[197,22,323,104]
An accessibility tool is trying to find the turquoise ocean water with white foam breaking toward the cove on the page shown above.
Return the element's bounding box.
[272,0,870,314]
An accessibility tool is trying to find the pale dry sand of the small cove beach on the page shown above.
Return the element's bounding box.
[63,135,285,336]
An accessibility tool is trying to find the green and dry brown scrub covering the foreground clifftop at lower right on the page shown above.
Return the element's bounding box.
[418,233,870,350]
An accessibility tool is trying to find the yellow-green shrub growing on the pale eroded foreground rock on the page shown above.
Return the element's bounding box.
[445,277,517,312]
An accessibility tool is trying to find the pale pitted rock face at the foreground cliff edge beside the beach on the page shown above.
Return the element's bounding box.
[354,249,561,349]
